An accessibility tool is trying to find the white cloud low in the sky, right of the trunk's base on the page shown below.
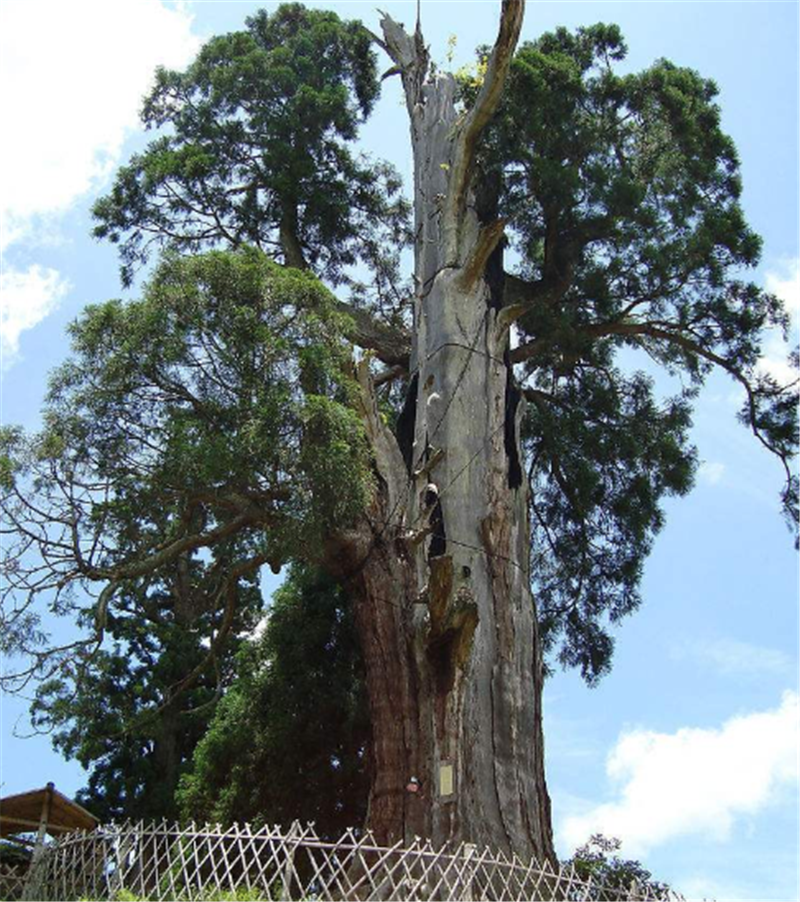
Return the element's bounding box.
[559,691,800,857]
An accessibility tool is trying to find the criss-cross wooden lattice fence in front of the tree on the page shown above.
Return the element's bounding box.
[28,821,682,902]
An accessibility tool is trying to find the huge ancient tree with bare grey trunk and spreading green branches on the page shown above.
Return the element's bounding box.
[3,0,797,858]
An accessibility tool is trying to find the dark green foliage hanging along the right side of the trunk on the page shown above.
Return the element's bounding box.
[460,24,798,683]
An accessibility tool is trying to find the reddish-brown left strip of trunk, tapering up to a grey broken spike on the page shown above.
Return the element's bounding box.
[326,362,427,844]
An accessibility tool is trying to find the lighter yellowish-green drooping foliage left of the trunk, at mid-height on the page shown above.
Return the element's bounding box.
[1,249,372,682]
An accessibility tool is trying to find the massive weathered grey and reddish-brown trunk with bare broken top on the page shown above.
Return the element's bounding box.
[324,0,554,859]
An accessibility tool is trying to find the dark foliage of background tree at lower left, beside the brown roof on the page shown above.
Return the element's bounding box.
[31,572,261,822]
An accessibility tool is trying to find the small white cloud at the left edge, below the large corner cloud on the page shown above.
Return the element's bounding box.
[0,264,69,370]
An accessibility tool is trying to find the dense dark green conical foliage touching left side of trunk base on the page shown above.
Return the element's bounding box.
[178,565,369,838]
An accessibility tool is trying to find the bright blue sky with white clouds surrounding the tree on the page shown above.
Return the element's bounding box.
[0,0,800,900]
